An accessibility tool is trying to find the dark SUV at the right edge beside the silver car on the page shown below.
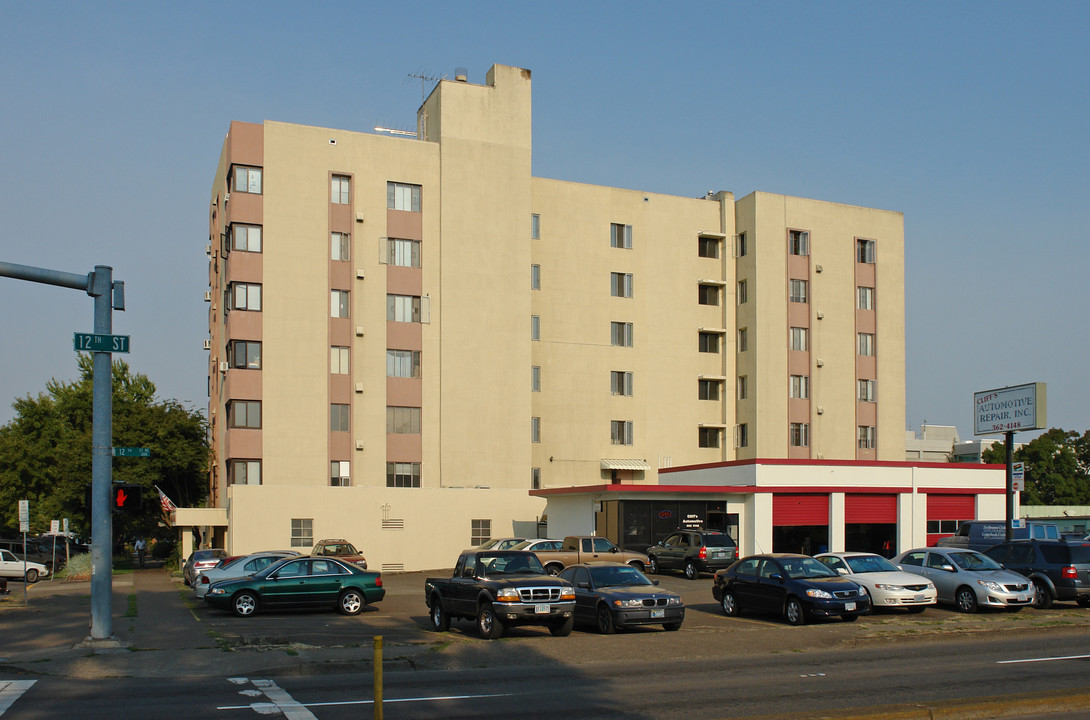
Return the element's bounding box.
[984,540,1090,610]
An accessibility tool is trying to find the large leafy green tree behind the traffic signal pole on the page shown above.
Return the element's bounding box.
[0,354,209,538]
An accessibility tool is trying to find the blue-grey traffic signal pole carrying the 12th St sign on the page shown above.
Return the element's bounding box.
[0,263,129,643]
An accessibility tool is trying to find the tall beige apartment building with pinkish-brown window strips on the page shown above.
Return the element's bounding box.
[175,65,989,570]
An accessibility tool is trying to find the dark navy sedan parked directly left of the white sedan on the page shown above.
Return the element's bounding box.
[712,553,871,625]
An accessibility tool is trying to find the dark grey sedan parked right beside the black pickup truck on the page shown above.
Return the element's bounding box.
[559,562,685,635]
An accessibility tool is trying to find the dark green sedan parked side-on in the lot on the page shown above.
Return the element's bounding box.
[204,557,386,618]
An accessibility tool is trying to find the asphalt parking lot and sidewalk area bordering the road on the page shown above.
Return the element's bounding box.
[0,568,1090,678]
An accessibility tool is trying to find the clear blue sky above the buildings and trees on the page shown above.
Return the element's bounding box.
[0,1,1090,439]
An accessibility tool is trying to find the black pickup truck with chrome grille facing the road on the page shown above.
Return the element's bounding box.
[424,548,576,639]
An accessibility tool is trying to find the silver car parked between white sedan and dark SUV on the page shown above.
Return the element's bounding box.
[893,548,1033,612]
